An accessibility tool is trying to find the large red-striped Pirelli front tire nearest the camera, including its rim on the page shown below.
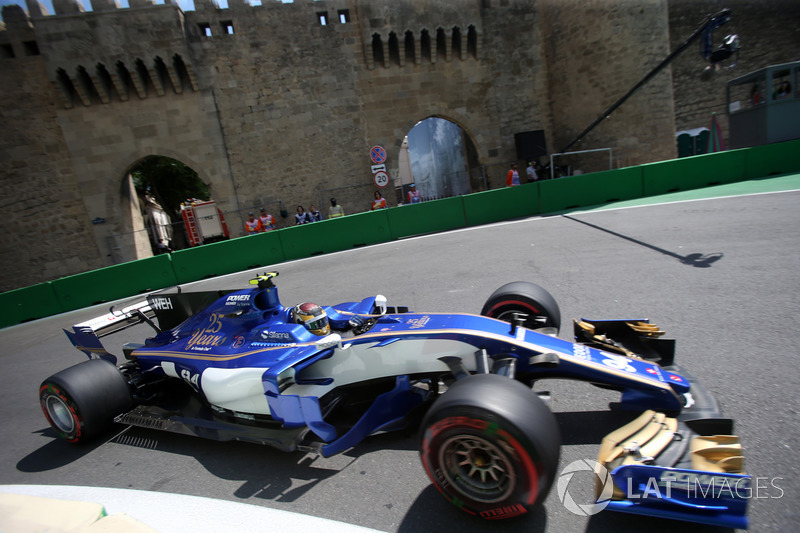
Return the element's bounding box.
[420,374,560,520]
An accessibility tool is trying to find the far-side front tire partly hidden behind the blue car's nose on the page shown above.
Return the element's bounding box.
[481,281,561,332]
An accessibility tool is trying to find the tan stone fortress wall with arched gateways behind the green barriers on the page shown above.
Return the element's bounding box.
[0,0,797,290]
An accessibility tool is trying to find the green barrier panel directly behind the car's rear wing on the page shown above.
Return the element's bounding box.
[51,254,177,311]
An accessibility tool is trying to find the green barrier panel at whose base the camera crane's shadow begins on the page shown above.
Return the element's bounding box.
[539,167,643,213]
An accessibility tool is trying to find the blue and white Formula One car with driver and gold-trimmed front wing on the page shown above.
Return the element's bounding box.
[39,272,750,528]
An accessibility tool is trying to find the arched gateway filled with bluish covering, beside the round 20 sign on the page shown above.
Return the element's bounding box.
[400,117,483,200]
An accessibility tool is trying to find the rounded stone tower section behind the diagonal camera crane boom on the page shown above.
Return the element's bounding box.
[542,0,677,167]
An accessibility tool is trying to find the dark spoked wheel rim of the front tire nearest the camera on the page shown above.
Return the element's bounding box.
[439,435,516,503]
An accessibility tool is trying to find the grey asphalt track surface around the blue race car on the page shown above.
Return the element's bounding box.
[0,175,800,533]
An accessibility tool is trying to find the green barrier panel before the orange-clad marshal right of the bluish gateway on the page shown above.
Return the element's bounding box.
[462,183,539,226]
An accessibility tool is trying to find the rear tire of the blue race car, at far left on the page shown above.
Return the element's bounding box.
[39,359,133,443]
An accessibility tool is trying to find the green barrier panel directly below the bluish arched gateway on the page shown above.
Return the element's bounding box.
[387,196,466,240]
